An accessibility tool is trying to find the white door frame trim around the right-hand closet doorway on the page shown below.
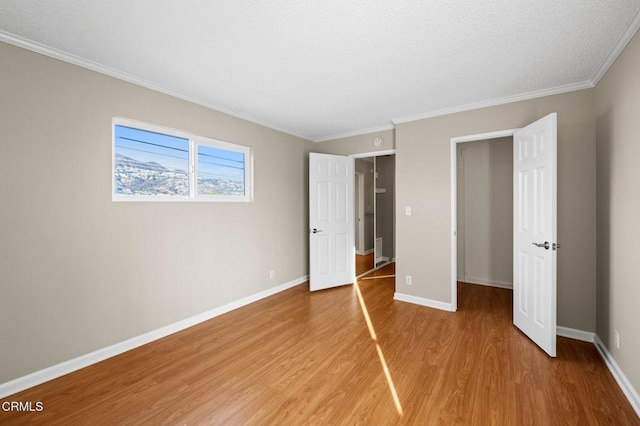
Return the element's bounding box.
[450,128,520,312]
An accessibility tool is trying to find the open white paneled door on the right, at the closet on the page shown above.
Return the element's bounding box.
[513,113,557,357]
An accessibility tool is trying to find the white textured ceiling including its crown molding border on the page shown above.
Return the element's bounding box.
[0,0,640,141]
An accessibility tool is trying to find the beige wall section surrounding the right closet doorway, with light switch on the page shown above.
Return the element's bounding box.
[396,90,595,331]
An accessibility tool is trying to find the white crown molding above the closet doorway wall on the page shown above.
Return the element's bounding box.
[391,81,595,126]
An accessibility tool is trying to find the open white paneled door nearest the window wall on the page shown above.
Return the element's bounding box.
[309,153,355,291]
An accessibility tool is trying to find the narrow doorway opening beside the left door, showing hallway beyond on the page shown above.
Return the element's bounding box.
[352,151,395,278]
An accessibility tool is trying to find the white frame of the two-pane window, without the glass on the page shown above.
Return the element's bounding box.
[111,117,253,203]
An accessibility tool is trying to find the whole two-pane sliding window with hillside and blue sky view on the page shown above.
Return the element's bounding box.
[113,119,251,201]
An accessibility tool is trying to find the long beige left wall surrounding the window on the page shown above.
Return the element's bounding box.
[0,43,313,383]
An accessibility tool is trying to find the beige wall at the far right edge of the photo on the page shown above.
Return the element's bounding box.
[595,30,640,391]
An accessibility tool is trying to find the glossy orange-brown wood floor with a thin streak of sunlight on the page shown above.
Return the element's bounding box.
[0,264,640,425]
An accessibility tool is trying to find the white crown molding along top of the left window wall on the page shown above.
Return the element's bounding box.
[0,30,313,141]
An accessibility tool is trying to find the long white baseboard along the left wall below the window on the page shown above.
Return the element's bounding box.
[0,276,309,399]
